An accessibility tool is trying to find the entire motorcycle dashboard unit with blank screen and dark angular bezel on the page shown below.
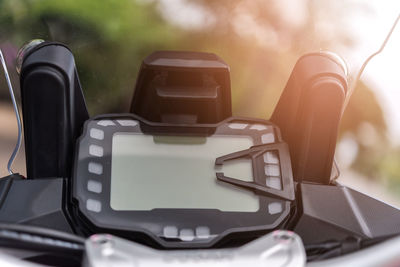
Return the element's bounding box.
[72,117,294,248]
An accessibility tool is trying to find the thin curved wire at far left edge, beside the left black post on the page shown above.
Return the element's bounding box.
[0,49,22,174]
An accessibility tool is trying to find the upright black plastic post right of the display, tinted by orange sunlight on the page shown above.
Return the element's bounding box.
[271,53,347,184]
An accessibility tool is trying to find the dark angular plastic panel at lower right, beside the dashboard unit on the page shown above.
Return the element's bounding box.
[294,184,400,244]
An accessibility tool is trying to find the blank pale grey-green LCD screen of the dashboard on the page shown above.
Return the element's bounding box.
[110,133,259,212]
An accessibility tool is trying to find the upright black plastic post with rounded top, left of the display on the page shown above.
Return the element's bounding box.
[20,42,89,179]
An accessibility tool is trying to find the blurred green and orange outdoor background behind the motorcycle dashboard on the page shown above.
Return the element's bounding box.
[0,0,400,207]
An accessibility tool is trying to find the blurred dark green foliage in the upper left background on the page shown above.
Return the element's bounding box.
[0,0,178,114]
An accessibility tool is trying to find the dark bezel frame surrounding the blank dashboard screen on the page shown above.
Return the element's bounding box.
[72,114,294,248]
